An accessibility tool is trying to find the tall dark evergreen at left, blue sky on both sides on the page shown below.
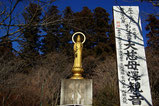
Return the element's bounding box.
[20,3,41,59]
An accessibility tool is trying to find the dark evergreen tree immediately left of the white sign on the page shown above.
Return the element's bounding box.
[94,7,114,58]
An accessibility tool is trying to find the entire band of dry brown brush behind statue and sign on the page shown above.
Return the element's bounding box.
[0,53,159,106]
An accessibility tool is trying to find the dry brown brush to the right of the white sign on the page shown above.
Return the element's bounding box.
[146,51,159,106]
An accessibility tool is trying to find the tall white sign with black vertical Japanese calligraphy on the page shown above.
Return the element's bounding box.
[113,6,152,106]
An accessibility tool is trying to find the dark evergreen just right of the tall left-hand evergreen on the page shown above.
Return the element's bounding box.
[41,6,61,54]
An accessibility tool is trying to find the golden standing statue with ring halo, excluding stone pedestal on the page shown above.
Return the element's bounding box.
[71,32,86,79]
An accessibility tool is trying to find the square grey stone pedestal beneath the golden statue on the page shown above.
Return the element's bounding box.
[60,79,93,106]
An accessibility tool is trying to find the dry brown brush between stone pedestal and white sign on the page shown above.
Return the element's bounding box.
[93,57,119,106]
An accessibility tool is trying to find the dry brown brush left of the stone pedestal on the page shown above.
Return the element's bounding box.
[0,53,72,106]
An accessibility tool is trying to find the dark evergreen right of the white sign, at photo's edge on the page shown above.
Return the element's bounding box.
[146,15,159,51]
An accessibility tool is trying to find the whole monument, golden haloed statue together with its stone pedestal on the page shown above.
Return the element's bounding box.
[60,32,93,106]
